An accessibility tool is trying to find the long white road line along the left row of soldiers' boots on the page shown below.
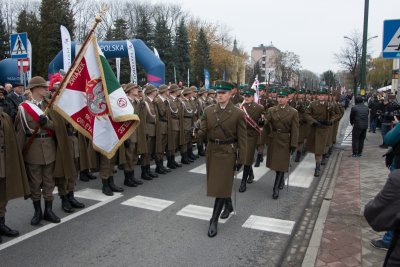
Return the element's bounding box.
[0,194,122,251]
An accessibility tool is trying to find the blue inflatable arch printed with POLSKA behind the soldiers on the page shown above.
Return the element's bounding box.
[0,39,165,86]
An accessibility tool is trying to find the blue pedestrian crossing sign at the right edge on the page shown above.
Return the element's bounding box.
[382,19,400,58]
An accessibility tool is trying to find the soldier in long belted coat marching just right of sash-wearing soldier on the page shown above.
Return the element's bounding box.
[266,89,299,199]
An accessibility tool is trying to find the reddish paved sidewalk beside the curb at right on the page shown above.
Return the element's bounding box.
[303,131,389,267]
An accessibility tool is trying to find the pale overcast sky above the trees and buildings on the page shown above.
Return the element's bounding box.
[152,0,400,73]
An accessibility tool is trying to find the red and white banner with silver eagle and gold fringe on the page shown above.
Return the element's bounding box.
[54,35,140,158]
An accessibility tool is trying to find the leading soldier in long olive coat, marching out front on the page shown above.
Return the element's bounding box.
[198,81,246,237]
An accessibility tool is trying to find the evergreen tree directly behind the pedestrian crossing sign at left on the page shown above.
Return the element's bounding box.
[17,9,41,75]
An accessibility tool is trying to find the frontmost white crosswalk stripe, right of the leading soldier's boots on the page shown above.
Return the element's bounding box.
[242,215,295,235]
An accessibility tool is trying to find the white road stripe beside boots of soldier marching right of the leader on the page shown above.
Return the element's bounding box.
[286,153,315,188]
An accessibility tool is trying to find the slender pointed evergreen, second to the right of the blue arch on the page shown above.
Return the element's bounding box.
[174,19,191,83]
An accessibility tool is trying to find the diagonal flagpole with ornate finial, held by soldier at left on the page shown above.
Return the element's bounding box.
[22,5,108,154]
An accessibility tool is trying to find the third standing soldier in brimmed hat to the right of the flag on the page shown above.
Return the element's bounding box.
[154,84,171,174]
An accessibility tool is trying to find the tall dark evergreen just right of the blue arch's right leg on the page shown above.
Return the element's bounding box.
[154,18,174,83]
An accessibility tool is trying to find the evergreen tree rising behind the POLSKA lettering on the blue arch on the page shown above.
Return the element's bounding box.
[106,18,131,83]
